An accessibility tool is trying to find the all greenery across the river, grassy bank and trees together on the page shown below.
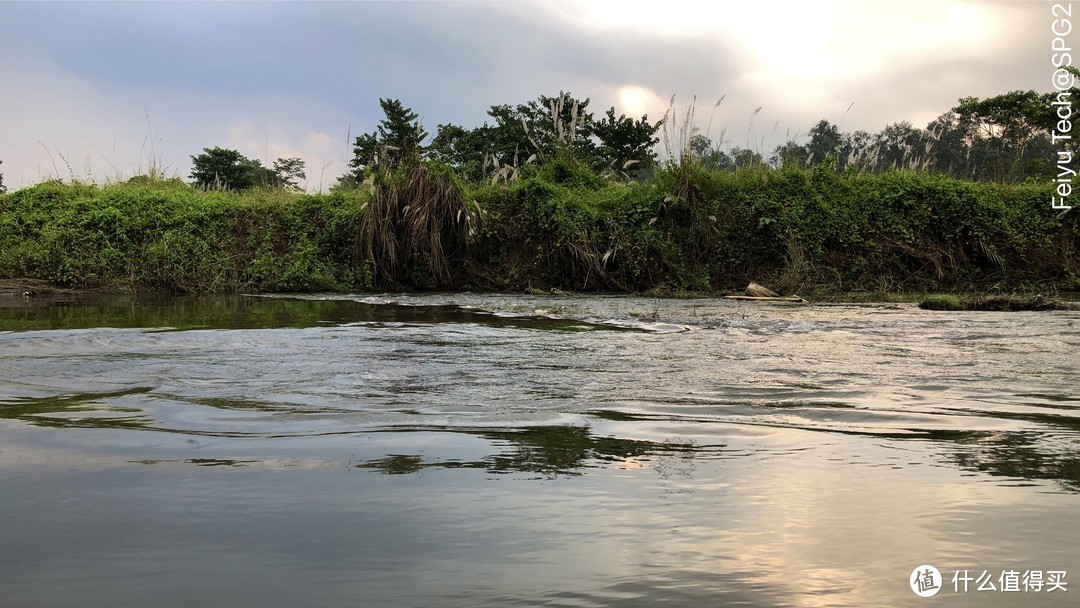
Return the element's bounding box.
[0,86,1080,301]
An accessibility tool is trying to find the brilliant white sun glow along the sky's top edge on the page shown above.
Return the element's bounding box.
[549,0,1002,80]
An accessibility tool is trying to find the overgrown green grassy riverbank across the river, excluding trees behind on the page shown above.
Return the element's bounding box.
[0,161,1080,296]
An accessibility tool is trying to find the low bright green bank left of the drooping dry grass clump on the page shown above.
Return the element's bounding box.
[0,181,370,292]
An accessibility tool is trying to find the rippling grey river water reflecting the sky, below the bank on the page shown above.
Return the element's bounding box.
[0,294,1080,607]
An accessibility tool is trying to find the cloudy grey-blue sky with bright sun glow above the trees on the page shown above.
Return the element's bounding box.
[0,0,1062,191]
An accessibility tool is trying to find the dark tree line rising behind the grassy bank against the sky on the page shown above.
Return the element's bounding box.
[190,72,1080,195]
